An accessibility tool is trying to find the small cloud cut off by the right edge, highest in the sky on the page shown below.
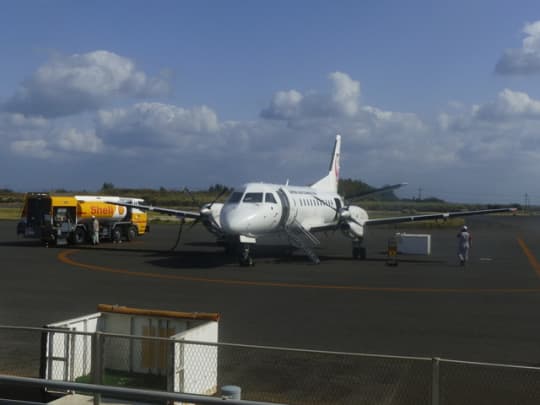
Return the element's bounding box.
[495,21,540,75]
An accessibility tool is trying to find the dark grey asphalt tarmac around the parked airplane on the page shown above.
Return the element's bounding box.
[0,216,540,400]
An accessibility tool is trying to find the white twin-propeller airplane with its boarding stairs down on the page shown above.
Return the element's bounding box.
[107,134,516,266]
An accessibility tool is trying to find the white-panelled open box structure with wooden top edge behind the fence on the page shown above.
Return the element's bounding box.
[42,305,218,395]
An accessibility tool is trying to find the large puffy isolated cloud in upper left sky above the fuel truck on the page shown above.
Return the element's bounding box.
[3,51,169,117]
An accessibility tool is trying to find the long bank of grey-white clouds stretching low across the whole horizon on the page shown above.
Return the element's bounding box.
[4,67,540,204]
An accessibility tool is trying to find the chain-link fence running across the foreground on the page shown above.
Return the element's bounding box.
[0,326,540,405]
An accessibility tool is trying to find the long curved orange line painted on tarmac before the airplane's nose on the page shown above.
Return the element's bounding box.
[58,249,540,293]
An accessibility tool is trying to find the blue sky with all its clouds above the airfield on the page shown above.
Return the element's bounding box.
[0,0,540,204]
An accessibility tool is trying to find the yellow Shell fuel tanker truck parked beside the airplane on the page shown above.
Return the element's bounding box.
[17,193,149,246]
